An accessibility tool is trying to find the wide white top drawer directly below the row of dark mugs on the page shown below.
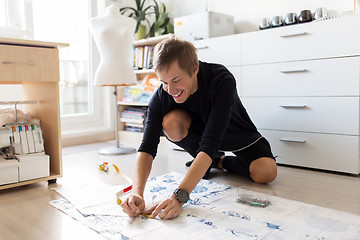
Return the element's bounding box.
[241,15,360,64]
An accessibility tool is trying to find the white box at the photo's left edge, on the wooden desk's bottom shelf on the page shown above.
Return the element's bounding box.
[0,156,19,185]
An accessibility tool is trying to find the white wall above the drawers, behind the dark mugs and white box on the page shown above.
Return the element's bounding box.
[162,0,354,33]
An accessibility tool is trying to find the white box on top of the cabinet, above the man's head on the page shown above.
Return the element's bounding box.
[174,11,235,41]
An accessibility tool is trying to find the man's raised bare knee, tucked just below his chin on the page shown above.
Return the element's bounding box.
[162,109,191,142]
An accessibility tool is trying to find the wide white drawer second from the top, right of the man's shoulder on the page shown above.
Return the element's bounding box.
[241,57,360,96]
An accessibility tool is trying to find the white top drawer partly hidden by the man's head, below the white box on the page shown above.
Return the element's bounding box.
[194,35,240,66]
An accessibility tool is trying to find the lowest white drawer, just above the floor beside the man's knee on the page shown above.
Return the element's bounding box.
[260,130,359,174]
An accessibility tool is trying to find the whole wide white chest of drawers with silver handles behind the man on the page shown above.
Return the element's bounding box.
[194,15,360,174]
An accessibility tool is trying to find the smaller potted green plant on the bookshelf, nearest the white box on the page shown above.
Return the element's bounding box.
[148,2,174,37]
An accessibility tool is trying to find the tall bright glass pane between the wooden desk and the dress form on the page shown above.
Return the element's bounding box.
[33,0,93,116]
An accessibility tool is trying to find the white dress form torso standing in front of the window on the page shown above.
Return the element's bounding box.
[90,5,136,86]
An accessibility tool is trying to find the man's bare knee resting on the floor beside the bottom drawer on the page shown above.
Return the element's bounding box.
[249,157,277,183]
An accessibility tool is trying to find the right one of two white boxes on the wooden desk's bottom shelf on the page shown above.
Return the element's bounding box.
[16,153,50,181]
